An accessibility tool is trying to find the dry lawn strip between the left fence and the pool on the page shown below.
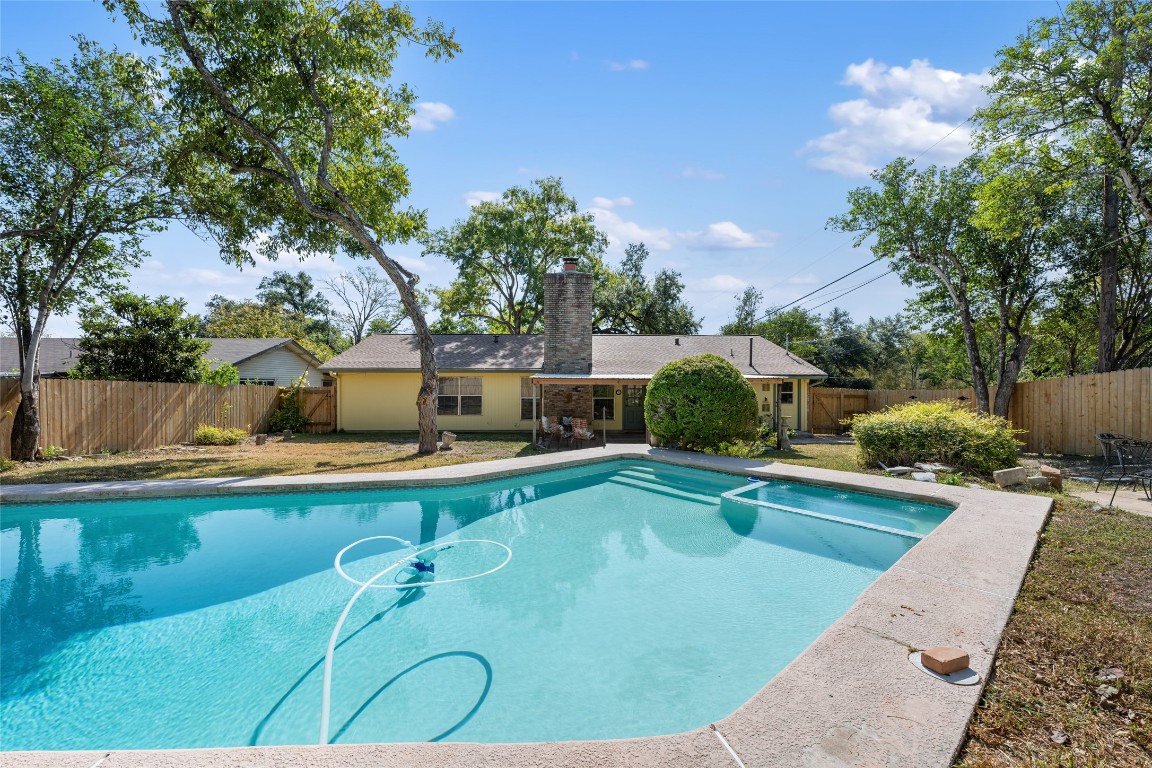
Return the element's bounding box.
[0,433,545,485]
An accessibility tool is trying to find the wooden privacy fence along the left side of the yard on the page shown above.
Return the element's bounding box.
[0,379,280,456]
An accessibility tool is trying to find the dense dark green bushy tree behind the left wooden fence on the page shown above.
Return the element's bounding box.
[74,292,209,383]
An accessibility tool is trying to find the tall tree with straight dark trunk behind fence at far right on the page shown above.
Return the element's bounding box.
[977,0,1152,371]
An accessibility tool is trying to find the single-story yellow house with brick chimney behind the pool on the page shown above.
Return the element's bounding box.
[324,263,826,432]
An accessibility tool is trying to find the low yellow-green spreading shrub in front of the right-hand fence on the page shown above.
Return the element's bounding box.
[851,401,1021,474]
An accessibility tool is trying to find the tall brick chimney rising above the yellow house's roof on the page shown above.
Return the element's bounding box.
[541,272,592,375]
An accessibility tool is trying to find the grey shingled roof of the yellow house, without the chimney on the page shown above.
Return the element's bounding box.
[324,334,826,379]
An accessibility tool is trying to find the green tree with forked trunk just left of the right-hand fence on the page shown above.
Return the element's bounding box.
[829,155,1052,416]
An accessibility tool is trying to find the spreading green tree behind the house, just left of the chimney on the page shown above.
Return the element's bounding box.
[424,178,608,334]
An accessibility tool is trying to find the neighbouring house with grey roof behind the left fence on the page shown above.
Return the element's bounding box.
[0,336,324,387]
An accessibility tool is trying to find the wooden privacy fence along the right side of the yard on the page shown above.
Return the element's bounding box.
[809,368,1152,455]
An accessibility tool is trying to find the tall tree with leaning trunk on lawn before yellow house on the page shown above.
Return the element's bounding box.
[116,0,460,453]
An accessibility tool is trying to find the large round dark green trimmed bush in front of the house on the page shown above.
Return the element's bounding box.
[644,355,758,450]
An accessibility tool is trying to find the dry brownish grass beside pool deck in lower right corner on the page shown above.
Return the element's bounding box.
[957,496,1152,768]
